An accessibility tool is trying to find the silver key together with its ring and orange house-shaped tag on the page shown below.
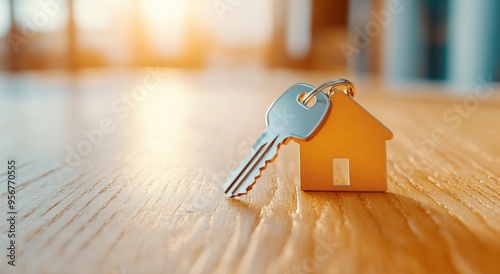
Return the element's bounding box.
[224,79,392,198]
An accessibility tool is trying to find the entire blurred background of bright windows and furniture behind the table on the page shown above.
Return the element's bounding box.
[0,0,500,87]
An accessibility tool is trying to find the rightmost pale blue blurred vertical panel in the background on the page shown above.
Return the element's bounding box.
[447,0,500,88]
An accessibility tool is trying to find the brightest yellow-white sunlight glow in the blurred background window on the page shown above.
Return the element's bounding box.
[142,0,188,56]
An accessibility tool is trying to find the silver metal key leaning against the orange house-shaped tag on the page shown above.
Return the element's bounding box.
[224,83,330,198]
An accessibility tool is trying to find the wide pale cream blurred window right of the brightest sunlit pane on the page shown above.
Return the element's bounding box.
[192,0,274,67]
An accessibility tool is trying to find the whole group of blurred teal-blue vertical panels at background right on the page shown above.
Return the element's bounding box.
[380,0,500,86]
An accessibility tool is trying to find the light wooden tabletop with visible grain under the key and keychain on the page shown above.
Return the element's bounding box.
[0,68,500,274]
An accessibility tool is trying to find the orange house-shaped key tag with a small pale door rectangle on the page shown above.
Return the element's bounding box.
[298,92,393,191]
